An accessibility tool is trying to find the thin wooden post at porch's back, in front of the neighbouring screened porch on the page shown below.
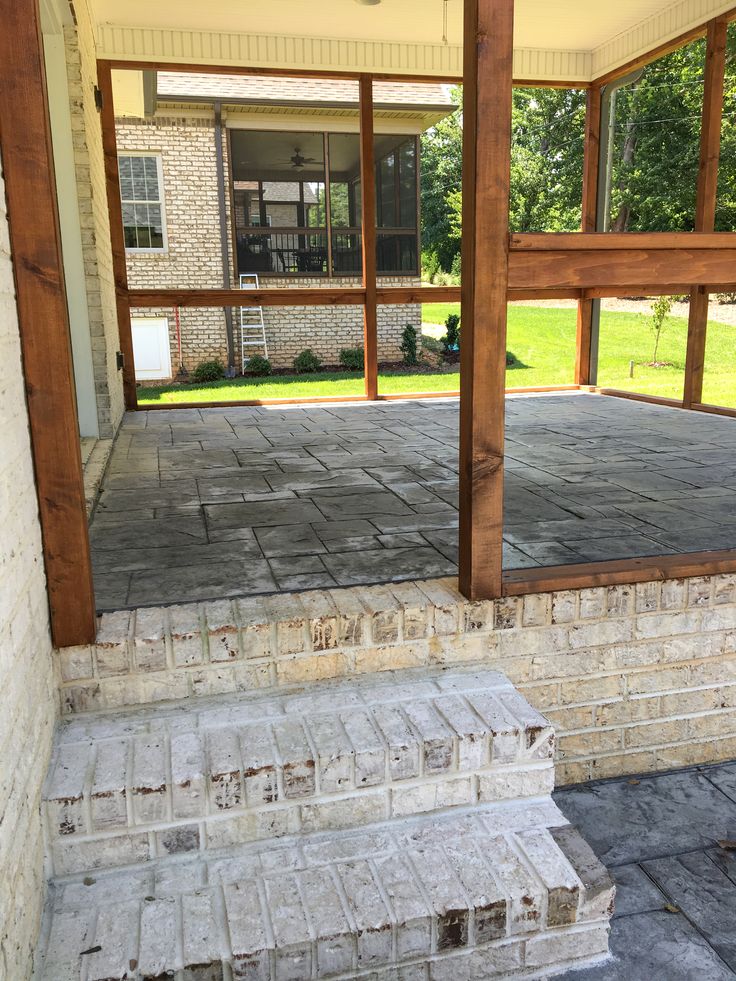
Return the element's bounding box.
[359,75,378,399]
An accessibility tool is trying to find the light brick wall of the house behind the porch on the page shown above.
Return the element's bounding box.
[116,117,422,374]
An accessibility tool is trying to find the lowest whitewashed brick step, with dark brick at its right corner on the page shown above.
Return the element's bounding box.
[39,800,614,981]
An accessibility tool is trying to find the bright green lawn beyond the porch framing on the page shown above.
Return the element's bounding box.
[138,303,736,406]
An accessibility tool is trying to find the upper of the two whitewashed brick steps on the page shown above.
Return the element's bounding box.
[44,669,554,874]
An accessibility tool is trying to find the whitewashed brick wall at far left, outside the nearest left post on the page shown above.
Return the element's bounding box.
[0,159,57,981]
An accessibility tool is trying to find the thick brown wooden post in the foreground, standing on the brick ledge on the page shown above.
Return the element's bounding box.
[459,0,514,599]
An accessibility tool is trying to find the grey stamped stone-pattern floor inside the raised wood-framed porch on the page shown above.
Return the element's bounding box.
[91,394,736,609]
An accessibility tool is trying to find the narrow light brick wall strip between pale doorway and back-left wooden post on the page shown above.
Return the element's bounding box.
[64,2,124,438]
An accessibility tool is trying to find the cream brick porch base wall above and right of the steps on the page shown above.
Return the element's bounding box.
[62,575,736,783]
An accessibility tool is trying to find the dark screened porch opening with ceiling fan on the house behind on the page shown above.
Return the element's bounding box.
[230,129,419,276]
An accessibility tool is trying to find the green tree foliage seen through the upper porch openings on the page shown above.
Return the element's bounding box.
[421,24,736,271]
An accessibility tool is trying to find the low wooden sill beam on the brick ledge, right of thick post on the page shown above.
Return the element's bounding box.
[503,549,736,596]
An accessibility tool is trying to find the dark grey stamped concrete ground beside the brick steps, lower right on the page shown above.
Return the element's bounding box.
[554,763,736,981]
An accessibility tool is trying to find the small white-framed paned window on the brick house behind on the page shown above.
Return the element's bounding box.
[118,154,166,252]
